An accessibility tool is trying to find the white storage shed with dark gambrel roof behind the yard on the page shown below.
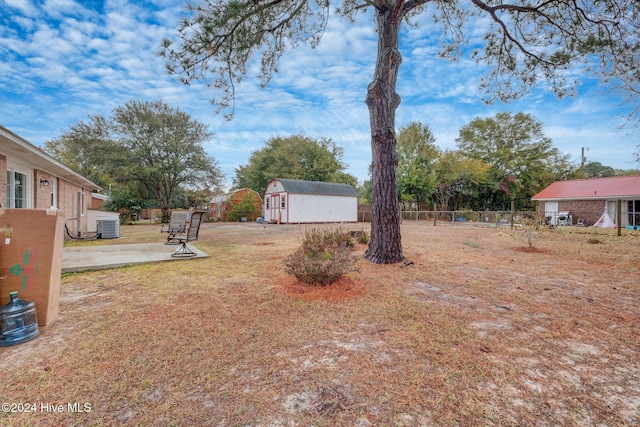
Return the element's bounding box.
[264,178,358,224]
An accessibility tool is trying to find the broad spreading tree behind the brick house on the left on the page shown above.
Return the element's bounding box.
[46,100,222,220]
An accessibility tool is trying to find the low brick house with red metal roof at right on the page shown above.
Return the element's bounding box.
[531,175,640,227]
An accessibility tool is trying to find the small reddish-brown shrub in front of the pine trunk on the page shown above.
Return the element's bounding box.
[284,229,356,285]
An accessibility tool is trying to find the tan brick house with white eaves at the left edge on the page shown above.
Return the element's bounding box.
[0,126,106,237]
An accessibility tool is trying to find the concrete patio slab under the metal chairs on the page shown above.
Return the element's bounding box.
[62,243,209,273]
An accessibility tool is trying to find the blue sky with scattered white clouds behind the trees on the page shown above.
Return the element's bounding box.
[0,0,640,191]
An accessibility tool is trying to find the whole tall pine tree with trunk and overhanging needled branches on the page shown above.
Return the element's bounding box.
[161,0,640,263]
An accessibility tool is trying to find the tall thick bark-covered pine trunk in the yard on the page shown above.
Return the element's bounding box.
[365,2,404,264]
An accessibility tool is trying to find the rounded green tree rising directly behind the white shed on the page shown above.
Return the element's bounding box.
[234,135,357,194]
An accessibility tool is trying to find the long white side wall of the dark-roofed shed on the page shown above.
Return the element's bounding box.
[282,194,358,223]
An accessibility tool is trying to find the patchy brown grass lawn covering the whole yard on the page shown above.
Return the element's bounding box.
[0,222,640,426]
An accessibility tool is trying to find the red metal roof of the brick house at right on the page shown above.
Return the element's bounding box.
[531,175,640,200]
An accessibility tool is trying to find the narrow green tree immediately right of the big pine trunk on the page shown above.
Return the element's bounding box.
[398,122,440,208]
